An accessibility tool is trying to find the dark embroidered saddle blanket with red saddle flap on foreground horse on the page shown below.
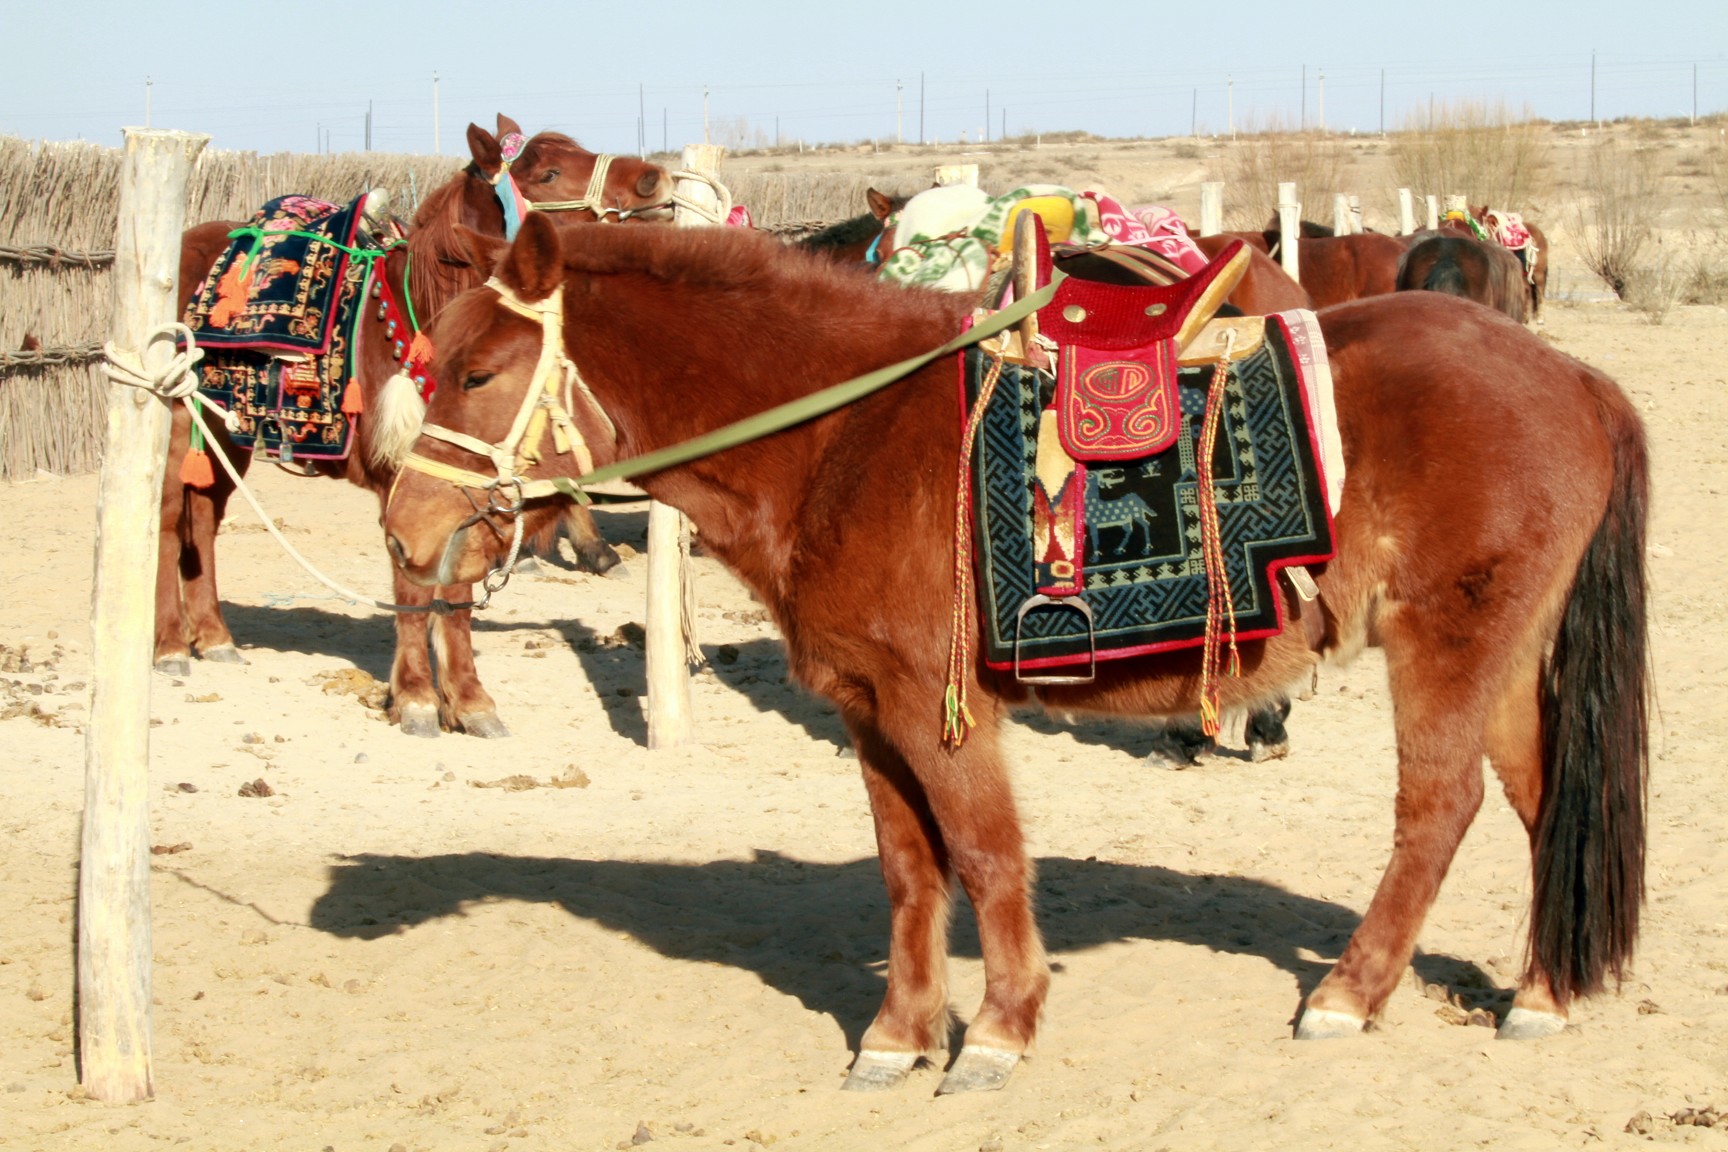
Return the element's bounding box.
[961,304,1341,670]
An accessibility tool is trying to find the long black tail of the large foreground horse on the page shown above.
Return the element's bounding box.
[1529,371,1650,1005]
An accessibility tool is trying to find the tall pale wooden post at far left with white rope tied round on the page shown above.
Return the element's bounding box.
[78,128,209,1104]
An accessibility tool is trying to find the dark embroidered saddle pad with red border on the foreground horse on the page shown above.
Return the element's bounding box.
[961,312,1332,670]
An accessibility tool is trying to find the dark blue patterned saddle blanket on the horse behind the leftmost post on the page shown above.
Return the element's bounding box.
[185,195,395,461]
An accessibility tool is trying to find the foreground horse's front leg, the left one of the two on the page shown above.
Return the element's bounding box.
[843,724,950,1092]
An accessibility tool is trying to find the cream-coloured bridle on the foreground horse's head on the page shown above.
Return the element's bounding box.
[385,276,617,590]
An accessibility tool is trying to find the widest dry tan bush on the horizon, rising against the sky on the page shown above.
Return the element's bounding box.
[1391,102,1552,211]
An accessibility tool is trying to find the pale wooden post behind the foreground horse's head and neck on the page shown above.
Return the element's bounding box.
[645,143,724,748]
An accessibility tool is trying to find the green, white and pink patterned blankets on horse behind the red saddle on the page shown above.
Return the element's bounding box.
[878,185,1206,292]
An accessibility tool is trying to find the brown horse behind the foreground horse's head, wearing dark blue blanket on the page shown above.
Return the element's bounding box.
[154,116,672,736]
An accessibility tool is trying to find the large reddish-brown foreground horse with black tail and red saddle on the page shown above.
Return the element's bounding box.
[385,219,1649,1090]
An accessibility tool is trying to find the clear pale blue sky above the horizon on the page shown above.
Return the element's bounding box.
[0,0,1728,155]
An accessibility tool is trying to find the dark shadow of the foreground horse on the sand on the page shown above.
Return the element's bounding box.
[311,850,1493,1048]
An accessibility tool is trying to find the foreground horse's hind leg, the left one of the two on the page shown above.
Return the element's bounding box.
[1296,645,1493,1040]
